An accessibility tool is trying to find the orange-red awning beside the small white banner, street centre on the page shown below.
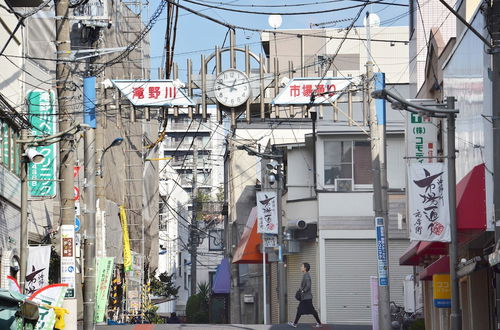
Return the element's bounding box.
[233,207,262,264]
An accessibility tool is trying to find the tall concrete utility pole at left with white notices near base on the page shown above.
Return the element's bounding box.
[56,0,77,329]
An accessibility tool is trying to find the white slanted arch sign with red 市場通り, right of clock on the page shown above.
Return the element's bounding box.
[272,78,352,105]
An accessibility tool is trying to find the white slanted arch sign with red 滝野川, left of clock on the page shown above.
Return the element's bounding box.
[112,80,195,107]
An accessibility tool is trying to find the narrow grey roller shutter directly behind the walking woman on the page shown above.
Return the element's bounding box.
[286,242,320,323]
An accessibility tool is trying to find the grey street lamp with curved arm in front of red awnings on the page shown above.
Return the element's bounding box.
[372,89,462,330]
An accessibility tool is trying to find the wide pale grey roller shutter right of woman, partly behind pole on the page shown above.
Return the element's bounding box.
[325,239,412,324]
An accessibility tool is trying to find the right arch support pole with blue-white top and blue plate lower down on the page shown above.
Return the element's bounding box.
[366,61,391,329]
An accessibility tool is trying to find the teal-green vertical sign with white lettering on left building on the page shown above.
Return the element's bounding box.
[27,91,57,197]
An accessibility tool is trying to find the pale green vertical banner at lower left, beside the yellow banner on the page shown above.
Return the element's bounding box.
[94,257,114,323]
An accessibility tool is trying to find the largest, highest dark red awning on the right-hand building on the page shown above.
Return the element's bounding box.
[457,164,486,232]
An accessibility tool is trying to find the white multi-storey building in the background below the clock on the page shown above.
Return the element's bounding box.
[158,111,226,315]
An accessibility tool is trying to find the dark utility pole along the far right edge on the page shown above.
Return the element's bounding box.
[489,0,500,330]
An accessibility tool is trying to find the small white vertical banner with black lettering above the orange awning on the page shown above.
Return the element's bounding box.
[257,191,278,234]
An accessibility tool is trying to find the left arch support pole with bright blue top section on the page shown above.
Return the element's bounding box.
[83,77,97,330]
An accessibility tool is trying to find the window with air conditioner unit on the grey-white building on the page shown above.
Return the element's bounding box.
[324,141,372,191]
